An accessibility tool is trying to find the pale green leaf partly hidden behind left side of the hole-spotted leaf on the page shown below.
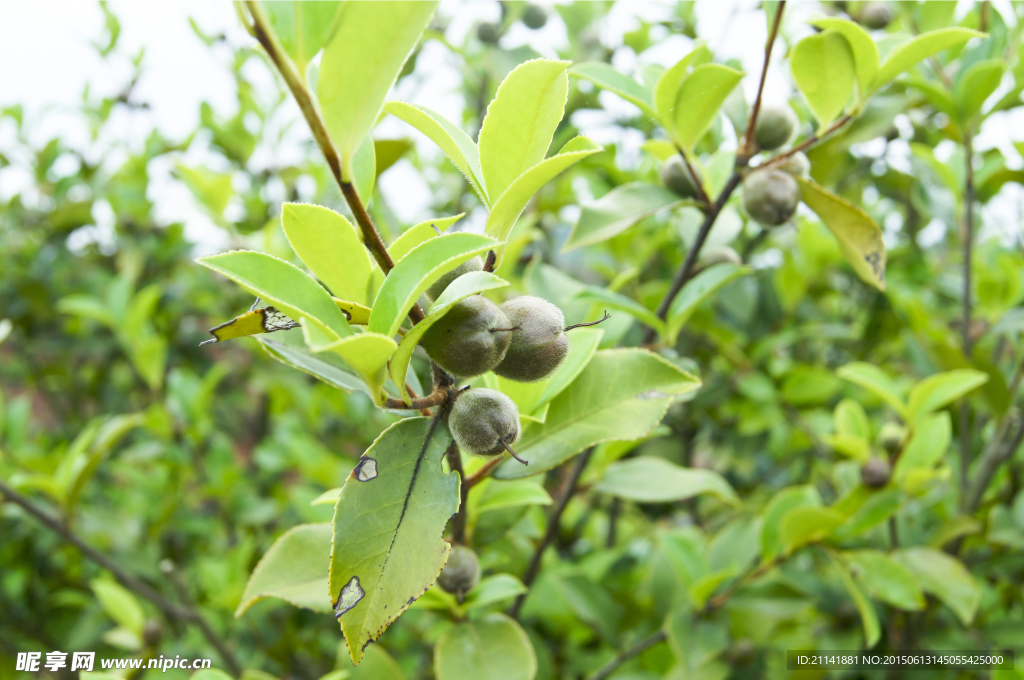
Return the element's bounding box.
[234,522,333,619]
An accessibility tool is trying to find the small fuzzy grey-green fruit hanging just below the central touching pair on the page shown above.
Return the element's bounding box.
[449,387,519,456]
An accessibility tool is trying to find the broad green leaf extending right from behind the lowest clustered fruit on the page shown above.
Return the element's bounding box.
[496,349,700,479]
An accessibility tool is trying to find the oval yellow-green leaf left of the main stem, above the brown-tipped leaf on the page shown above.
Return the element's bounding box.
[281,203,375,304]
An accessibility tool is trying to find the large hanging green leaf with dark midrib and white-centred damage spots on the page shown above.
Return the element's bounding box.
[330,418,459,664]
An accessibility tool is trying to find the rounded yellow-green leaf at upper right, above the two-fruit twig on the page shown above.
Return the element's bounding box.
[790,31,857,131]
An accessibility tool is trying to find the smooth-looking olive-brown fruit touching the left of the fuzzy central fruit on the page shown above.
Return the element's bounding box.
[422,295,512,378]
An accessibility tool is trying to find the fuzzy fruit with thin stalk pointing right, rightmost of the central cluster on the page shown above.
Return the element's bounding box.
[495,295,569,382]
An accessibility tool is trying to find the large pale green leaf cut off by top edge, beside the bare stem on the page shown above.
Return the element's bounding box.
[316,1,437,181]
